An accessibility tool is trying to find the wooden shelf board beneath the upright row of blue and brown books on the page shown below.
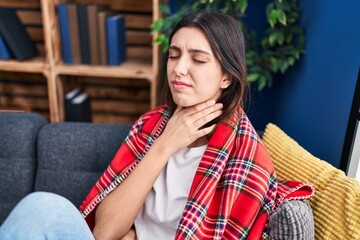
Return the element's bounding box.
[55,59,154,80]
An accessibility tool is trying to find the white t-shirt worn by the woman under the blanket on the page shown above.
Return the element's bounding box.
[134,145,206,240]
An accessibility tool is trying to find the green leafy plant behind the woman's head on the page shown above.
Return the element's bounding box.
[152,0,305,90]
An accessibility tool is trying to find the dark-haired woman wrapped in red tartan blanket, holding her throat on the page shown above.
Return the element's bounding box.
[0,11,277,239]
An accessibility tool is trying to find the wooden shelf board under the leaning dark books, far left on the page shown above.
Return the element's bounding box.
[0,57,49,73]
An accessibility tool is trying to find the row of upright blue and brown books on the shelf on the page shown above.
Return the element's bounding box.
[57,3,126,65]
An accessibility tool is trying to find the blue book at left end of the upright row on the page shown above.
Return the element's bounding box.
[57,3,73,64]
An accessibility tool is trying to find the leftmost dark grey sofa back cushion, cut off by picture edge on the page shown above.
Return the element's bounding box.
[0,112,47,224]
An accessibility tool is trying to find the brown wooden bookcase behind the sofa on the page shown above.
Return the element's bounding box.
[0,0,162,123]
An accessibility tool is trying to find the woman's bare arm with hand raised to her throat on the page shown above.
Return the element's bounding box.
[93,101,222,240]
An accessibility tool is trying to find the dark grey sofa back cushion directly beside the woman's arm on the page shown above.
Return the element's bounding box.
[35,122,130,206]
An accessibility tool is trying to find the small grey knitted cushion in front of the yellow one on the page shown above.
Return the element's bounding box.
[269,200,314,240]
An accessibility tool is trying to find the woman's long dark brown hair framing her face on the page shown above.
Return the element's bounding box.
[162,10,248,119]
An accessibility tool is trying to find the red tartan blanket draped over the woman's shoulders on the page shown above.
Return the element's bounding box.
[80,106,314,239]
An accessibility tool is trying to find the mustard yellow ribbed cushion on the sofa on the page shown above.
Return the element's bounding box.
[263,123,360,240]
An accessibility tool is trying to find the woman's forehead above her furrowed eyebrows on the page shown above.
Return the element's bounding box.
[170,27,212,53]
